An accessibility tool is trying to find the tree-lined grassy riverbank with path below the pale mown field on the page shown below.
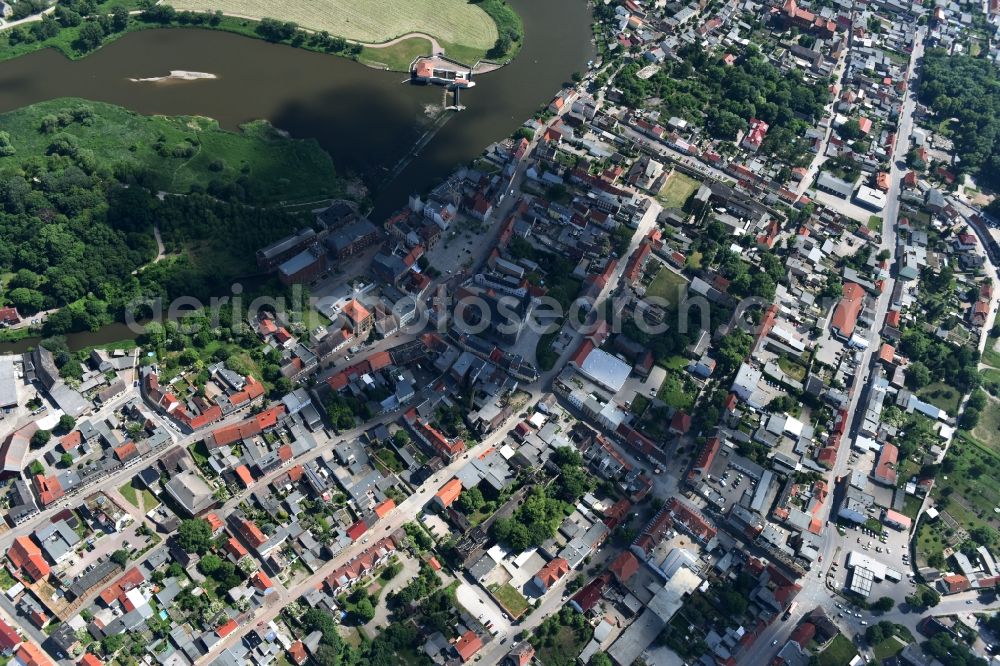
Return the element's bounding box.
[0,0,524,71]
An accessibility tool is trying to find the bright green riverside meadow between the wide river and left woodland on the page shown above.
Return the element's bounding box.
[0,98,340,201]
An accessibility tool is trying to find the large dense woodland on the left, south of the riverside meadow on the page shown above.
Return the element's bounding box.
[0,119,314,333]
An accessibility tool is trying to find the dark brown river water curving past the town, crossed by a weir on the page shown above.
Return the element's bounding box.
[0,0,593,353]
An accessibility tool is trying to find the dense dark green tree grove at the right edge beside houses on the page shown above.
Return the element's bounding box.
[918,49,1000,187]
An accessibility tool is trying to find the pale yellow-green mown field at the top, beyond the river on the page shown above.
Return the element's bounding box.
[170,0,497,51]
